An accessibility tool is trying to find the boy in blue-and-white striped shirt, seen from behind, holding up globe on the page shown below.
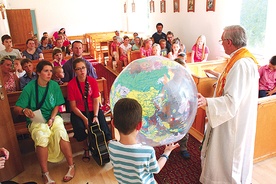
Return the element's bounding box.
[108,98,179,184]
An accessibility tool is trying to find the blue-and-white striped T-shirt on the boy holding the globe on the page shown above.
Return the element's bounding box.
[108,141,160,184]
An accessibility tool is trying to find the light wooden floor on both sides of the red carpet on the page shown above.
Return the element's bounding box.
[12,136,276,184]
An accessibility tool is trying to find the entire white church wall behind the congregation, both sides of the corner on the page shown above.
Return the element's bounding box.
[0,0,240,59]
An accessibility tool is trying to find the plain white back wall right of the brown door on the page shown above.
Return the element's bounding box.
[4,0,123,37]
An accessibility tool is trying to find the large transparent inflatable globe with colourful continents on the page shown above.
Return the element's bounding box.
[110,56,197,147]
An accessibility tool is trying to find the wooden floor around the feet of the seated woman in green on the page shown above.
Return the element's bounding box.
[12,136,117,184]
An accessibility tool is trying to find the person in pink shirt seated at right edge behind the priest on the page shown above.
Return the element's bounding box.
[259,56,276,98]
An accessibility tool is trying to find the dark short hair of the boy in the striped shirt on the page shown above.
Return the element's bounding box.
[113,98,142,135]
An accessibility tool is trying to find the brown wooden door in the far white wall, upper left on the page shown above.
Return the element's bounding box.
[6,9,34,43]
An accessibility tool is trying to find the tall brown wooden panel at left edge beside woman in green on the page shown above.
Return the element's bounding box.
[0,70,24,182]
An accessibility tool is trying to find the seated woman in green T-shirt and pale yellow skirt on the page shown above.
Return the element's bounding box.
[15,60,75,184]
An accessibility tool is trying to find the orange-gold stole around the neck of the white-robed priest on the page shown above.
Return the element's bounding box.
[216,48,258,97]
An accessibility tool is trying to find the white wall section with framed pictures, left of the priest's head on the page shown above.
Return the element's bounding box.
[147,0,240,59]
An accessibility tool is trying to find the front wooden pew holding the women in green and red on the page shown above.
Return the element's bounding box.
[7,77,114,135]
